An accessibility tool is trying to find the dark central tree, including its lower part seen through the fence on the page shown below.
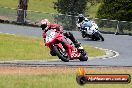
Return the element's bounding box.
[54,0,88,30]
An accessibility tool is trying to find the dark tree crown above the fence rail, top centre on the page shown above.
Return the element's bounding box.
[54,0,88,15]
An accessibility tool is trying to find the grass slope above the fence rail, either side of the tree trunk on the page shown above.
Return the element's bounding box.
[0,0,57,13]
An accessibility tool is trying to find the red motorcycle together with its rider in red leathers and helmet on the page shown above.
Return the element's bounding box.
[41,19,88,62]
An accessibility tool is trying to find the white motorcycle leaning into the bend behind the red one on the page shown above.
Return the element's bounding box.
[80,22,104,41]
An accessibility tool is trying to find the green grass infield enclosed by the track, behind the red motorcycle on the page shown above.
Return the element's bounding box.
[0,34,105,60]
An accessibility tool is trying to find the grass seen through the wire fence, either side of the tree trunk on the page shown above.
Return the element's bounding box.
[0,8,55,23]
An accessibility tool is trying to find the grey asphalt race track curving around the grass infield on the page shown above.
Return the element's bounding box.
[0,24,132,66]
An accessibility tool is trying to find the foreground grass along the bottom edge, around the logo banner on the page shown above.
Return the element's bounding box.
[0,68,132,88]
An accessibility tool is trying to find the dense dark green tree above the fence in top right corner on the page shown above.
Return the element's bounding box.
[97,0,132,21]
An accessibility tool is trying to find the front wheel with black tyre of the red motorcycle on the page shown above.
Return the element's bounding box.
[53,46,70,62]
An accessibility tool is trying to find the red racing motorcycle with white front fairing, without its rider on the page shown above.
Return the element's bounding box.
[45,29,88,62]
